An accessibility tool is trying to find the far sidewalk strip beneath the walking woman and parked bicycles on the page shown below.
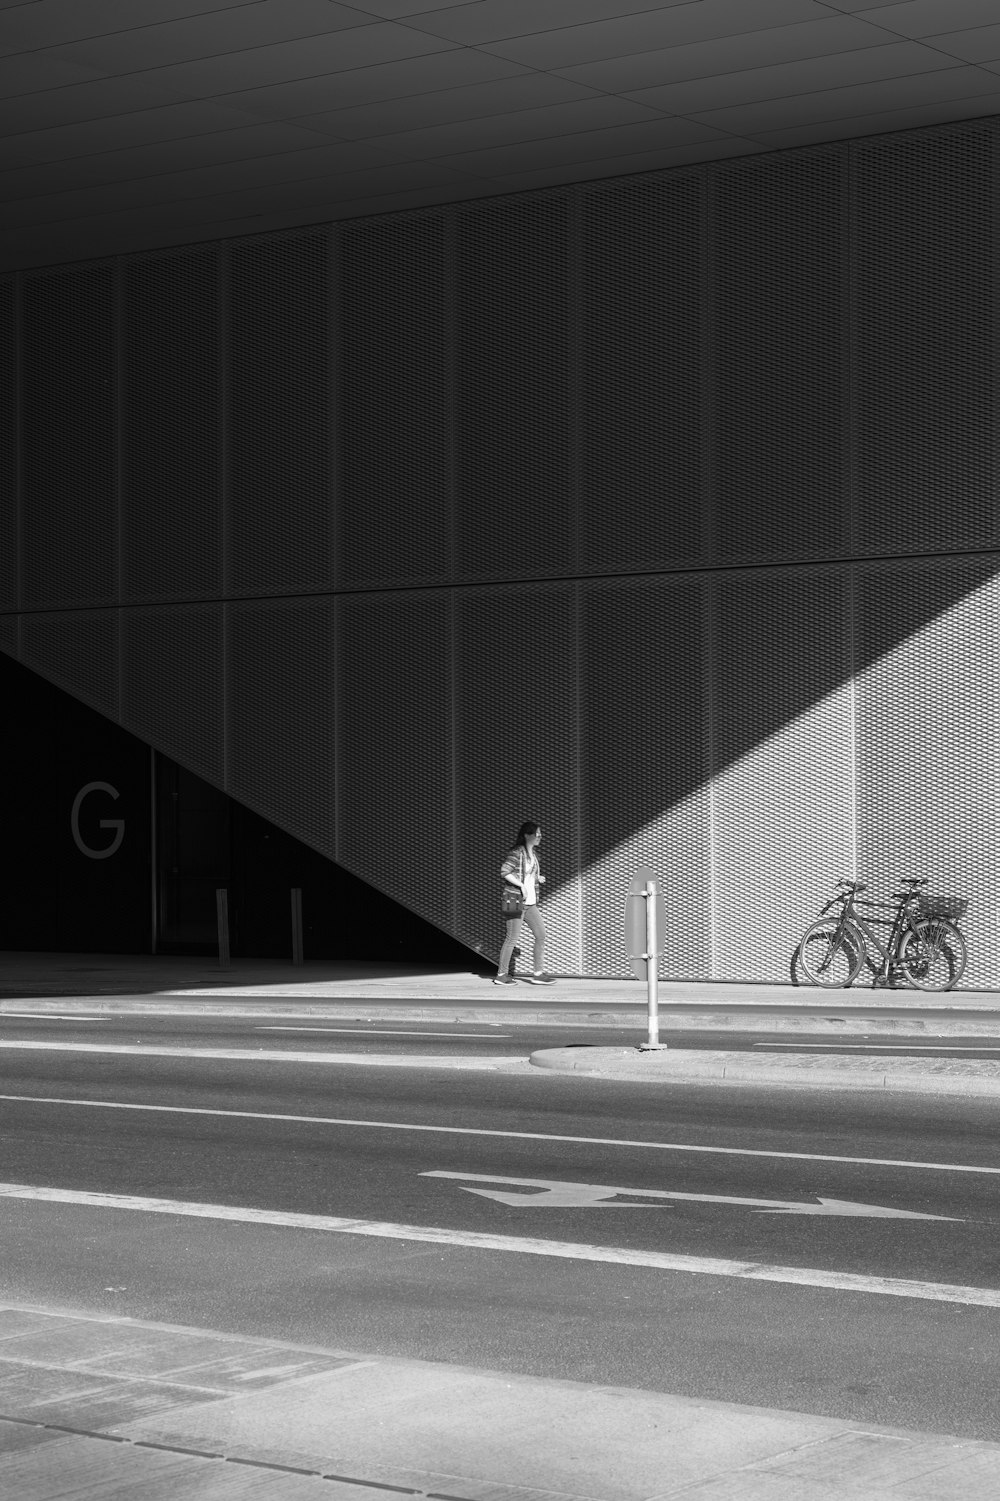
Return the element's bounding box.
[0,952,1000,1036]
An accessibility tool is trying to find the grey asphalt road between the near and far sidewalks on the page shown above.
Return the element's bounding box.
[0,1016,1000,1439]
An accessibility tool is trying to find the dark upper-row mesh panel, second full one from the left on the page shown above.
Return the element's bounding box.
[122,249,222,600]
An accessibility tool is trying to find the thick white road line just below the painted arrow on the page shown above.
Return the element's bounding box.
[0,1183,1000,1309]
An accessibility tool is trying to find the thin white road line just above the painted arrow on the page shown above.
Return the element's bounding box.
[0,1094,1000,1177]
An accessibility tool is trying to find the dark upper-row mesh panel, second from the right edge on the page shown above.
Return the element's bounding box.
[712,152,847,561]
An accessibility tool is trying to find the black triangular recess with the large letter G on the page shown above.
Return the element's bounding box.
[0,656,468,968]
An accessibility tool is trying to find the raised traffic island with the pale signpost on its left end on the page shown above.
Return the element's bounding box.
[529,1048,1000,1099]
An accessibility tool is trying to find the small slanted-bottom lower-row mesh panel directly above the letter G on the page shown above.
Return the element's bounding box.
[21,609,119,719]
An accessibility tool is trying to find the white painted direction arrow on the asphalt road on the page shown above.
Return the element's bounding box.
[420,1172,961,1223]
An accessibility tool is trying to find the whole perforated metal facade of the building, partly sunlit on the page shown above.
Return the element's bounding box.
[0,120,1000,985]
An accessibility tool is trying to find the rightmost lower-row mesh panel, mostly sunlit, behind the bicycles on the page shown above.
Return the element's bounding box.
[857,560,1000,989]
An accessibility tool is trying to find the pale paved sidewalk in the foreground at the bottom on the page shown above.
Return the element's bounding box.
[0,1306,1000,1501]
